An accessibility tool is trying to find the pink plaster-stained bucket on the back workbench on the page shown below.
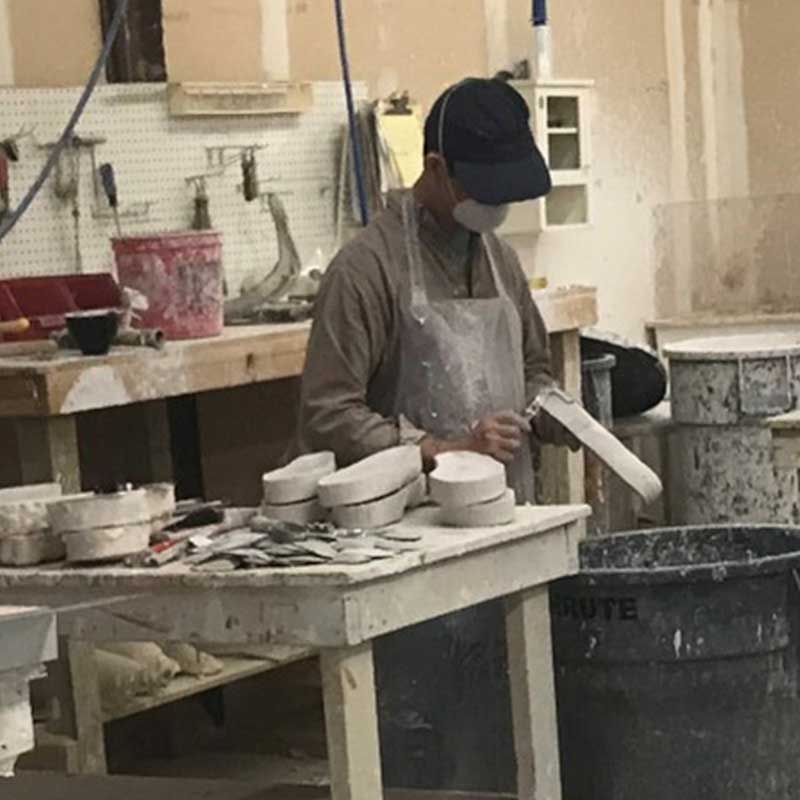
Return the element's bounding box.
[111,231,224,339]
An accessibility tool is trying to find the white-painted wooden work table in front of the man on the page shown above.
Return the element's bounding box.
[0,506,589,800]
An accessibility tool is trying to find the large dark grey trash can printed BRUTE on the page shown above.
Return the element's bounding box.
[551,526,800,800]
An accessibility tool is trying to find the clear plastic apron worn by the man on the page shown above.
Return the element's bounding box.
[394,192,534,503]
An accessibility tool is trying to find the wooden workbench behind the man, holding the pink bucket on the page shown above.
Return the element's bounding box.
[0,287,597,503]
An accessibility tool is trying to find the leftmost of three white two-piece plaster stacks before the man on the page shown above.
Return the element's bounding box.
[261,452,336,525]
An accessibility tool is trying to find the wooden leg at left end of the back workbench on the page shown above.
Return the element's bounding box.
[14,416,81,494]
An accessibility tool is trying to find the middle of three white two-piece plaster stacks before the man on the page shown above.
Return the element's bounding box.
[319,445,427,530]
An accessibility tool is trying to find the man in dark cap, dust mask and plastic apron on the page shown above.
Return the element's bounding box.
[300,79,568,502]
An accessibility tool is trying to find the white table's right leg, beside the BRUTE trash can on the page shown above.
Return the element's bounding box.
[506,586,561,800]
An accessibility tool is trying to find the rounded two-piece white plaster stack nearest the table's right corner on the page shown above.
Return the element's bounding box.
[430,451,516,528]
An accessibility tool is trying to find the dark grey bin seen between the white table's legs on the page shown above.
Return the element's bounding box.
[373,601,516,796]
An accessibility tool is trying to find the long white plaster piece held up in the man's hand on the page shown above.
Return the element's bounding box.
[526,387,663,503]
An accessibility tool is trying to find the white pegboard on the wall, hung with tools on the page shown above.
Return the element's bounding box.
[0,83,366,294]
